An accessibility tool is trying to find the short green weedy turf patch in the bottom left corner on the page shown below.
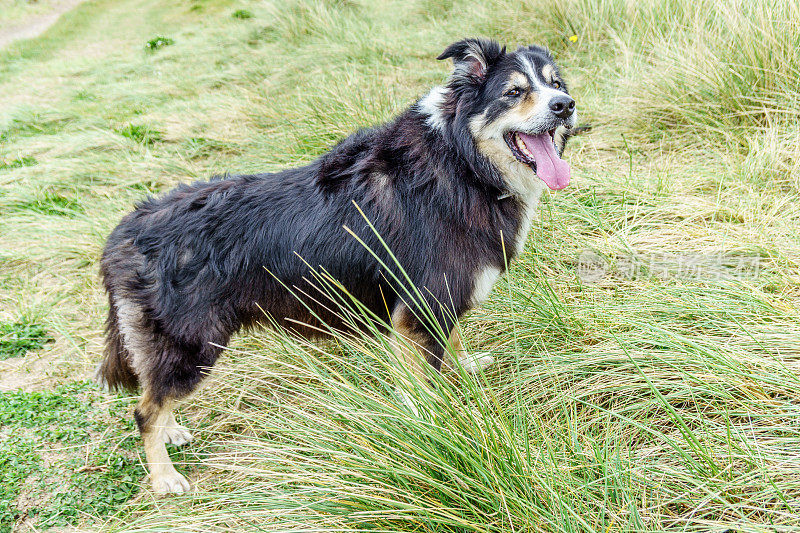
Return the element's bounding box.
[0,382,144,533]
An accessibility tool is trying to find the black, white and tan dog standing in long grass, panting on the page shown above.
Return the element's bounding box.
[98,39,576,493]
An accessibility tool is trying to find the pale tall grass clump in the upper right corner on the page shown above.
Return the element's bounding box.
[622,0,800,151]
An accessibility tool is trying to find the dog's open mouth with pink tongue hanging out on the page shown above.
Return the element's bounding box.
[504,130,570,190]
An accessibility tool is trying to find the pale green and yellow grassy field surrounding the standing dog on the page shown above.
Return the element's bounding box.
[0,0,800,533]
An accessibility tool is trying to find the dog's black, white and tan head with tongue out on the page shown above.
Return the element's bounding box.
[420,39,576,192]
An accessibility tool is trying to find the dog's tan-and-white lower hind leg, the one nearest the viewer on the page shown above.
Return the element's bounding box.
[135,387,190,494]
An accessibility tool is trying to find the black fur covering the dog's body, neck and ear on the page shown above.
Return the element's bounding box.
[101,37,572,404]
